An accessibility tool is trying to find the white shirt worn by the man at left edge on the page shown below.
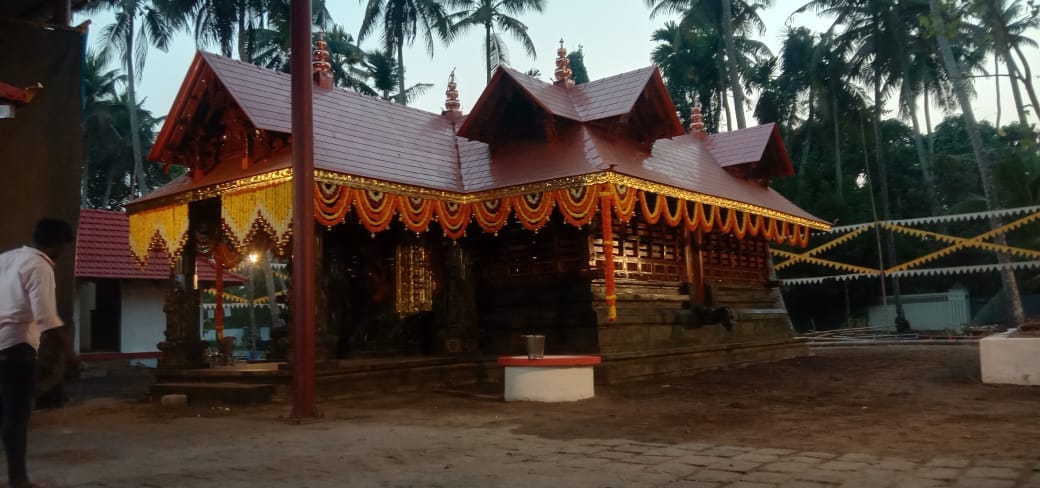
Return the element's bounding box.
[0,246,64,351]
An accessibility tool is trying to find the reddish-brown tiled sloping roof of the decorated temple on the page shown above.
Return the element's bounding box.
[135,53,825,223]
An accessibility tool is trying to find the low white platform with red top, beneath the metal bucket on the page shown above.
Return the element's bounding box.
[498,356,600,402]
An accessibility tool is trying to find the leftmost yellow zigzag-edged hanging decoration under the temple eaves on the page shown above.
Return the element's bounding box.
[129,204,188,267]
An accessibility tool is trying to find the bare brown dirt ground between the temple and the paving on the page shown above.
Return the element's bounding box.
[48,345,1040,461]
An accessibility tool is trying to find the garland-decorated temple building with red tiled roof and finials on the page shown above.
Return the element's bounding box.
[127,42,829,389]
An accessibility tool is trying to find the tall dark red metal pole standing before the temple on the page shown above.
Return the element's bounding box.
[289,0,319,418]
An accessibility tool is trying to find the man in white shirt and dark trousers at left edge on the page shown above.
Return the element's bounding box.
[0,219,74,488]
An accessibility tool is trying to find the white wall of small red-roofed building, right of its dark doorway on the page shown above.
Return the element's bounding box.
[120,280,168,353]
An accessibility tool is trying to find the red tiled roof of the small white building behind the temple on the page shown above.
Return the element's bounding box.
[76,208,245,283]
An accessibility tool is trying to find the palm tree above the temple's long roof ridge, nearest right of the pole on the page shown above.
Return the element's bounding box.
[358,0,451,105]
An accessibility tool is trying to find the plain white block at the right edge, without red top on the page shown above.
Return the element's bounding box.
[979,330,1040,385]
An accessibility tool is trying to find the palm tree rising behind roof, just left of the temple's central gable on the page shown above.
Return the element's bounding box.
[448,0,545,81]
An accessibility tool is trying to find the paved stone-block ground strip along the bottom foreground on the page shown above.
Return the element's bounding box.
[14,403,1040,488]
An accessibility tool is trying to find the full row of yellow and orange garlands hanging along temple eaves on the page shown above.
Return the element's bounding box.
[131,175,818,262]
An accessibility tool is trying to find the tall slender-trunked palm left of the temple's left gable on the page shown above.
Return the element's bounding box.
[92,0,176,195]
